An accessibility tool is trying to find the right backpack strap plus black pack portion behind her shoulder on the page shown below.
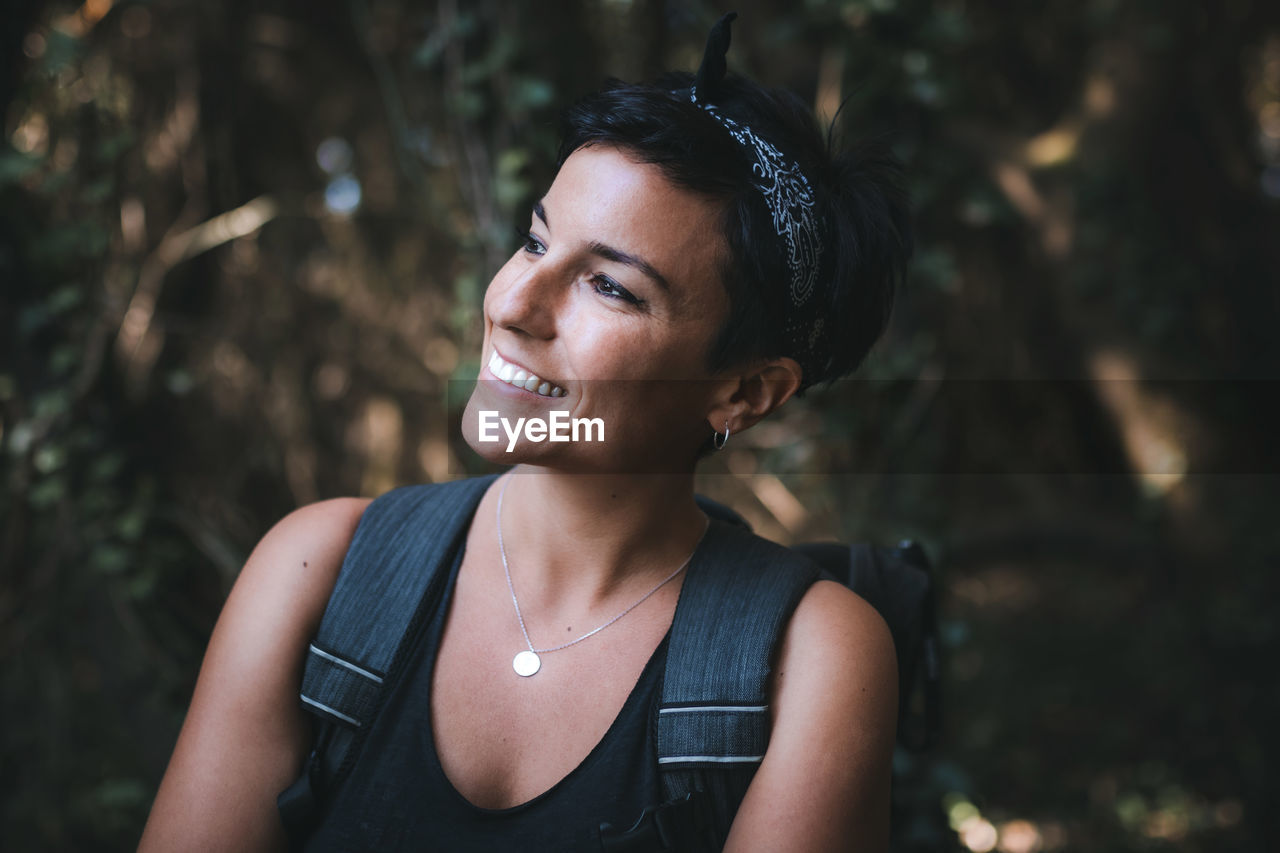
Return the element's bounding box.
[600,496,940,853]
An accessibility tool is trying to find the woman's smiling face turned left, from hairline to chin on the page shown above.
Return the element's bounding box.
[463,146,728,473]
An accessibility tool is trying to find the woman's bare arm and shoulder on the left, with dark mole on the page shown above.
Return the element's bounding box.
[138,498,369,853]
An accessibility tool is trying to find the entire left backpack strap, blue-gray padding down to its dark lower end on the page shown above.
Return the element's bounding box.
[276,476,494,843]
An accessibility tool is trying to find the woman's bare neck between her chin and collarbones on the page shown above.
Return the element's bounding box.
[498,466,707,610]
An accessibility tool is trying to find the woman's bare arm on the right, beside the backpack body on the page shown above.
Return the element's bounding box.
[724,581,897,853]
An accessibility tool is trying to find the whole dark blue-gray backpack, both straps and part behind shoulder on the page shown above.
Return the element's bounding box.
[278,475,938,853]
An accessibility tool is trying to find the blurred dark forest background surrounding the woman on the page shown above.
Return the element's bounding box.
[0,0,1280,853]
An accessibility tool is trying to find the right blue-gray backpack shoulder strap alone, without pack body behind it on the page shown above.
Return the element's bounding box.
[657,520,819,849]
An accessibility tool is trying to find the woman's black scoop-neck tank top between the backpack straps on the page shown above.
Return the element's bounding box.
[305,537,668,853]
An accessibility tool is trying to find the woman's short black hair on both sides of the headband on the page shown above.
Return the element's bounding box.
[557,73,911,388]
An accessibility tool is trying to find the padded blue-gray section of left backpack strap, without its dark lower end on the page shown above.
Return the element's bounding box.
[301,476,494,729]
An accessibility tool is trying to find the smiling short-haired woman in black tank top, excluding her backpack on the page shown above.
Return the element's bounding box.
[142,15,910,850]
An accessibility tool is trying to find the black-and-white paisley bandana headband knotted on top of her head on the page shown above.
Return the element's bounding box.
[689,12,823,380]
